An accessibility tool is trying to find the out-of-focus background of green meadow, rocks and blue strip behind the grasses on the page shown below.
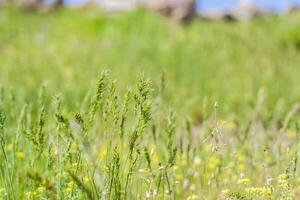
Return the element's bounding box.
[0,0,300,116]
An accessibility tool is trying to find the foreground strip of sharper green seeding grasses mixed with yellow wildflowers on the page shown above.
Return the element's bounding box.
[0,71,300,199]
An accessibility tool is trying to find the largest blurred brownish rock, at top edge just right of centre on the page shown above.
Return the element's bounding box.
[139,0,196,22]
